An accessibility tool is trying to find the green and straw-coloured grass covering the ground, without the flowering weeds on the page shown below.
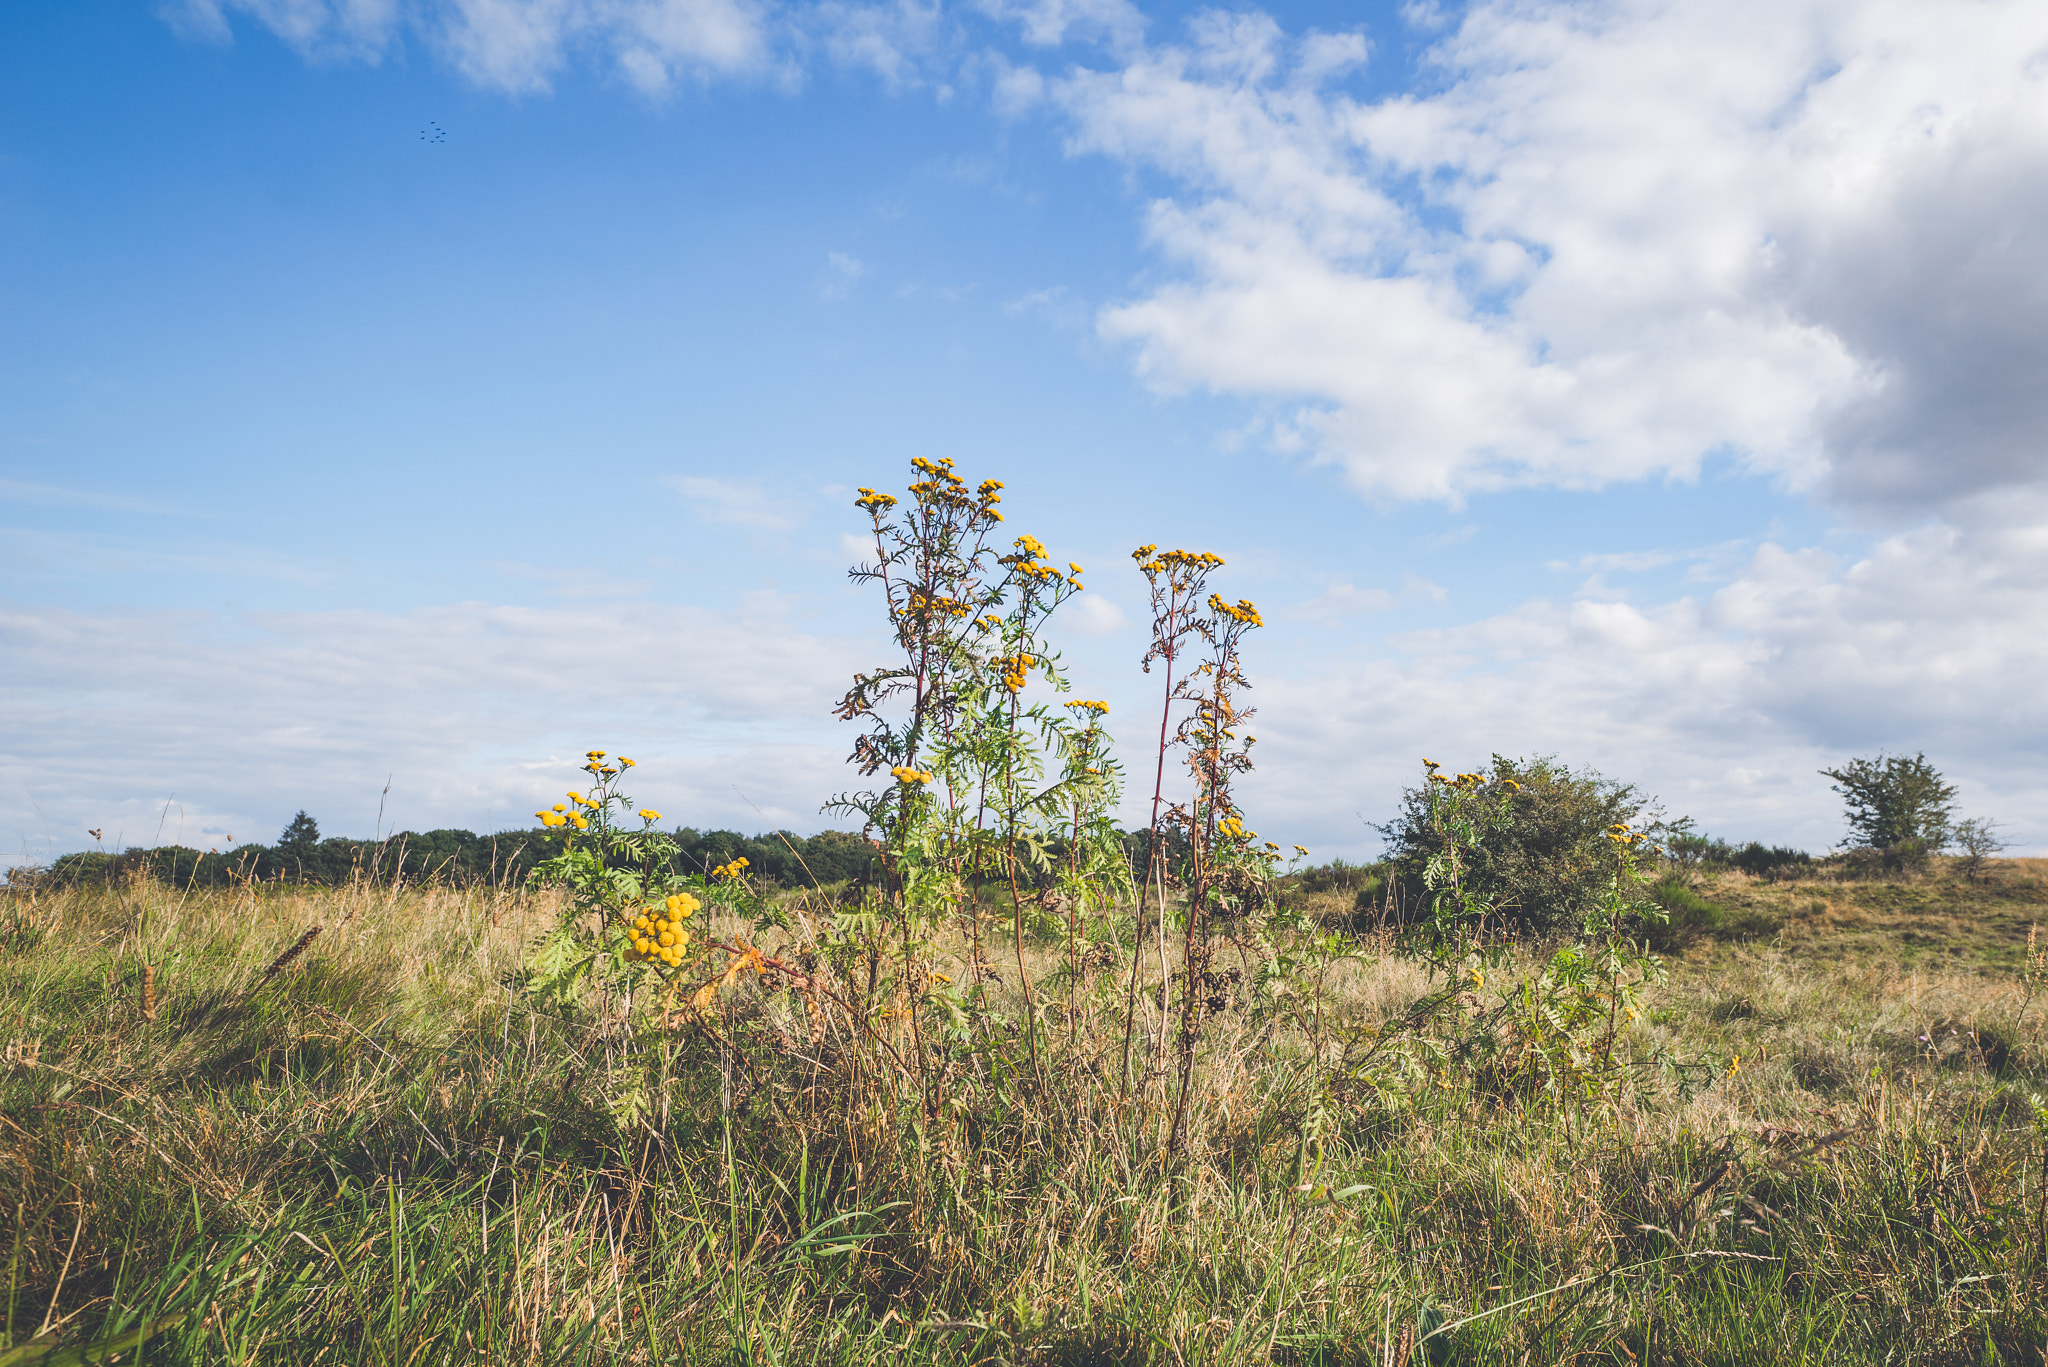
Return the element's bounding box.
[0,861,2048,1367]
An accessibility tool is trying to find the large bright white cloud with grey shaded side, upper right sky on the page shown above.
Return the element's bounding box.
[1057,0,2048,508]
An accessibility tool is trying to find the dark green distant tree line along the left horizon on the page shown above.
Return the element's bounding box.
[39,812,874,887]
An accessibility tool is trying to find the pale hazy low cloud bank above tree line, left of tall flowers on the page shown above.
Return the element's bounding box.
[0,598,856,859]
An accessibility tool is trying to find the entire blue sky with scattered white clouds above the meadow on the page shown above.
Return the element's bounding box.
[0,0,2048,863]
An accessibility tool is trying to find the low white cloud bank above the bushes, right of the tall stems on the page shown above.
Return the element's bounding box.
[1253,506,2048,851]
